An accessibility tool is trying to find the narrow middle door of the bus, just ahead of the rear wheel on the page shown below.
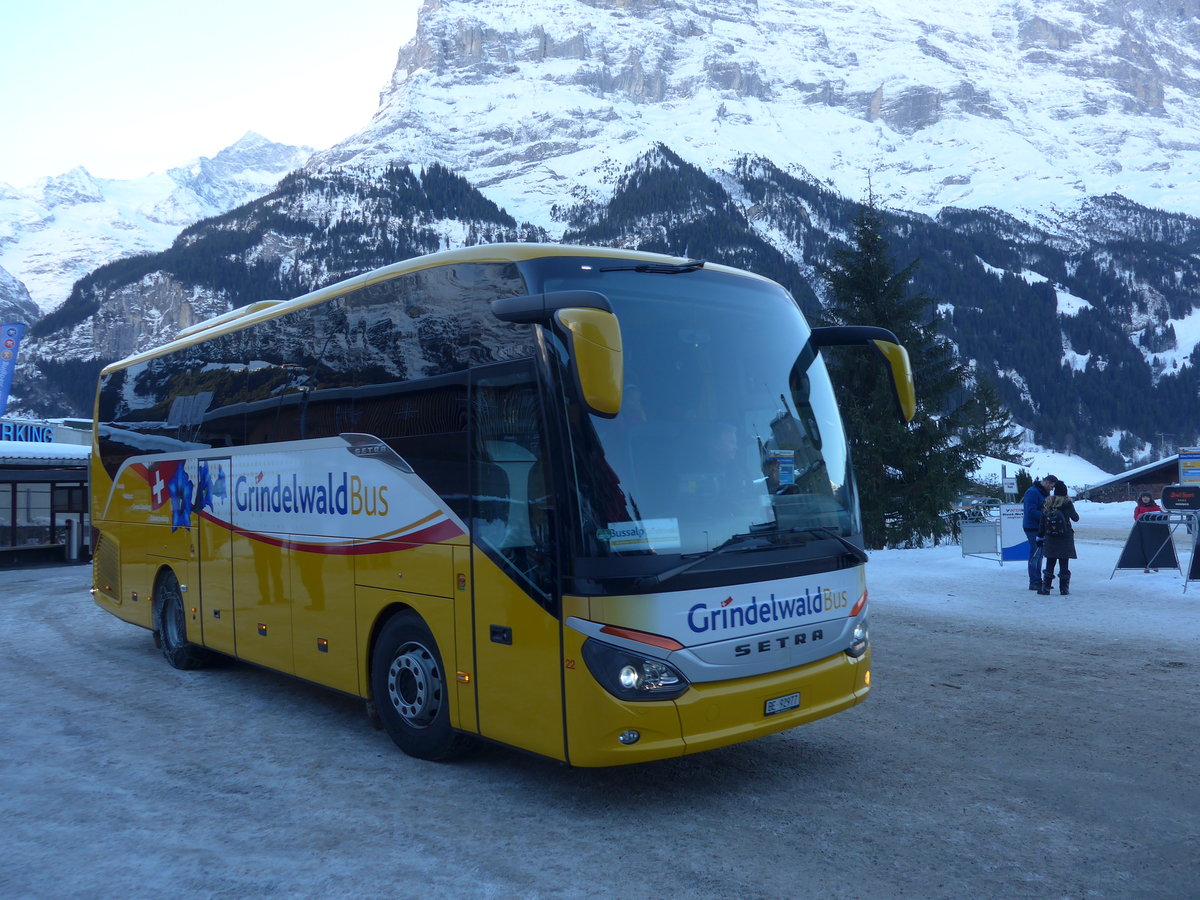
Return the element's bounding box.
[193,457,236,655]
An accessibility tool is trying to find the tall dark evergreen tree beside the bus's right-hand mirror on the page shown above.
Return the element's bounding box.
[822,200,1016,548]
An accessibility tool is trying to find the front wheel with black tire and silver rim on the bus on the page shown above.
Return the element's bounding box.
[371,610,473,760]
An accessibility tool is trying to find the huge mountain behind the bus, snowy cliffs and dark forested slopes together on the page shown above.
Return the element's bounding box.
[7,0,1200,475]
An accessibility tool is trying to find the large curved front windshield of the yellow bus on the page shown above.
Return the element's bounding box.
[539,258,862,565]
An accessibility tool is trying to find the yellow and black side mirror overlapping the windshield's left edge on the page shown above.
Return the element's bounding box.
[492,290,624,419]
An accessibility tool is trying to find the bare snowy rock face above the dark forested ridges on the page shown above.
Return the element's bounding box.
[310,0,1200,224]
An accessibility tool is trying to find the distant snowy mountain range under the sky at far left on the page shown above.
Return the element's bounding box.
[0,132,312,318]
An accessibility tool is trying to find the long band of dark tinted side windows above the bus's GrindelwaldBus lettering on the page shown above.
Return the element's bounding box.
[100,256,534,482]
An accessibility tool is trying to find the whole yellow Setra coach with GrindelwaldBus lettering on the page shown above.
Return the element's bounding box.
[91,244,914,766]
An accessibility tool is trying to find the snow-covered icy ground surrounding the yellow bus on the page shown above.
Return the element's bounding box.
[0,494,1200,900]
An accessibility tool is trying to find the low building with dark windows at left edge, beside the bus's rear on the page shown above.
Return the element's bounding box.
[0,419,91,568]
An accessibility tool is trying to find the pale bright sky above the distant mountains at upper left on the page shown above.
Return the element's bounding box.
[0,0,420,187]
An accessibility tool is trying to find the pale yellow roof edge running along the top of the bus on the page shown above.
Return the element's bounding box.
[102,244,770,373]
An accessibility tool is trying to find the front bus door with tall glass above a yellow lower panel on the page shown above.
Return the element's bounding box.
[469,361,565,760]
